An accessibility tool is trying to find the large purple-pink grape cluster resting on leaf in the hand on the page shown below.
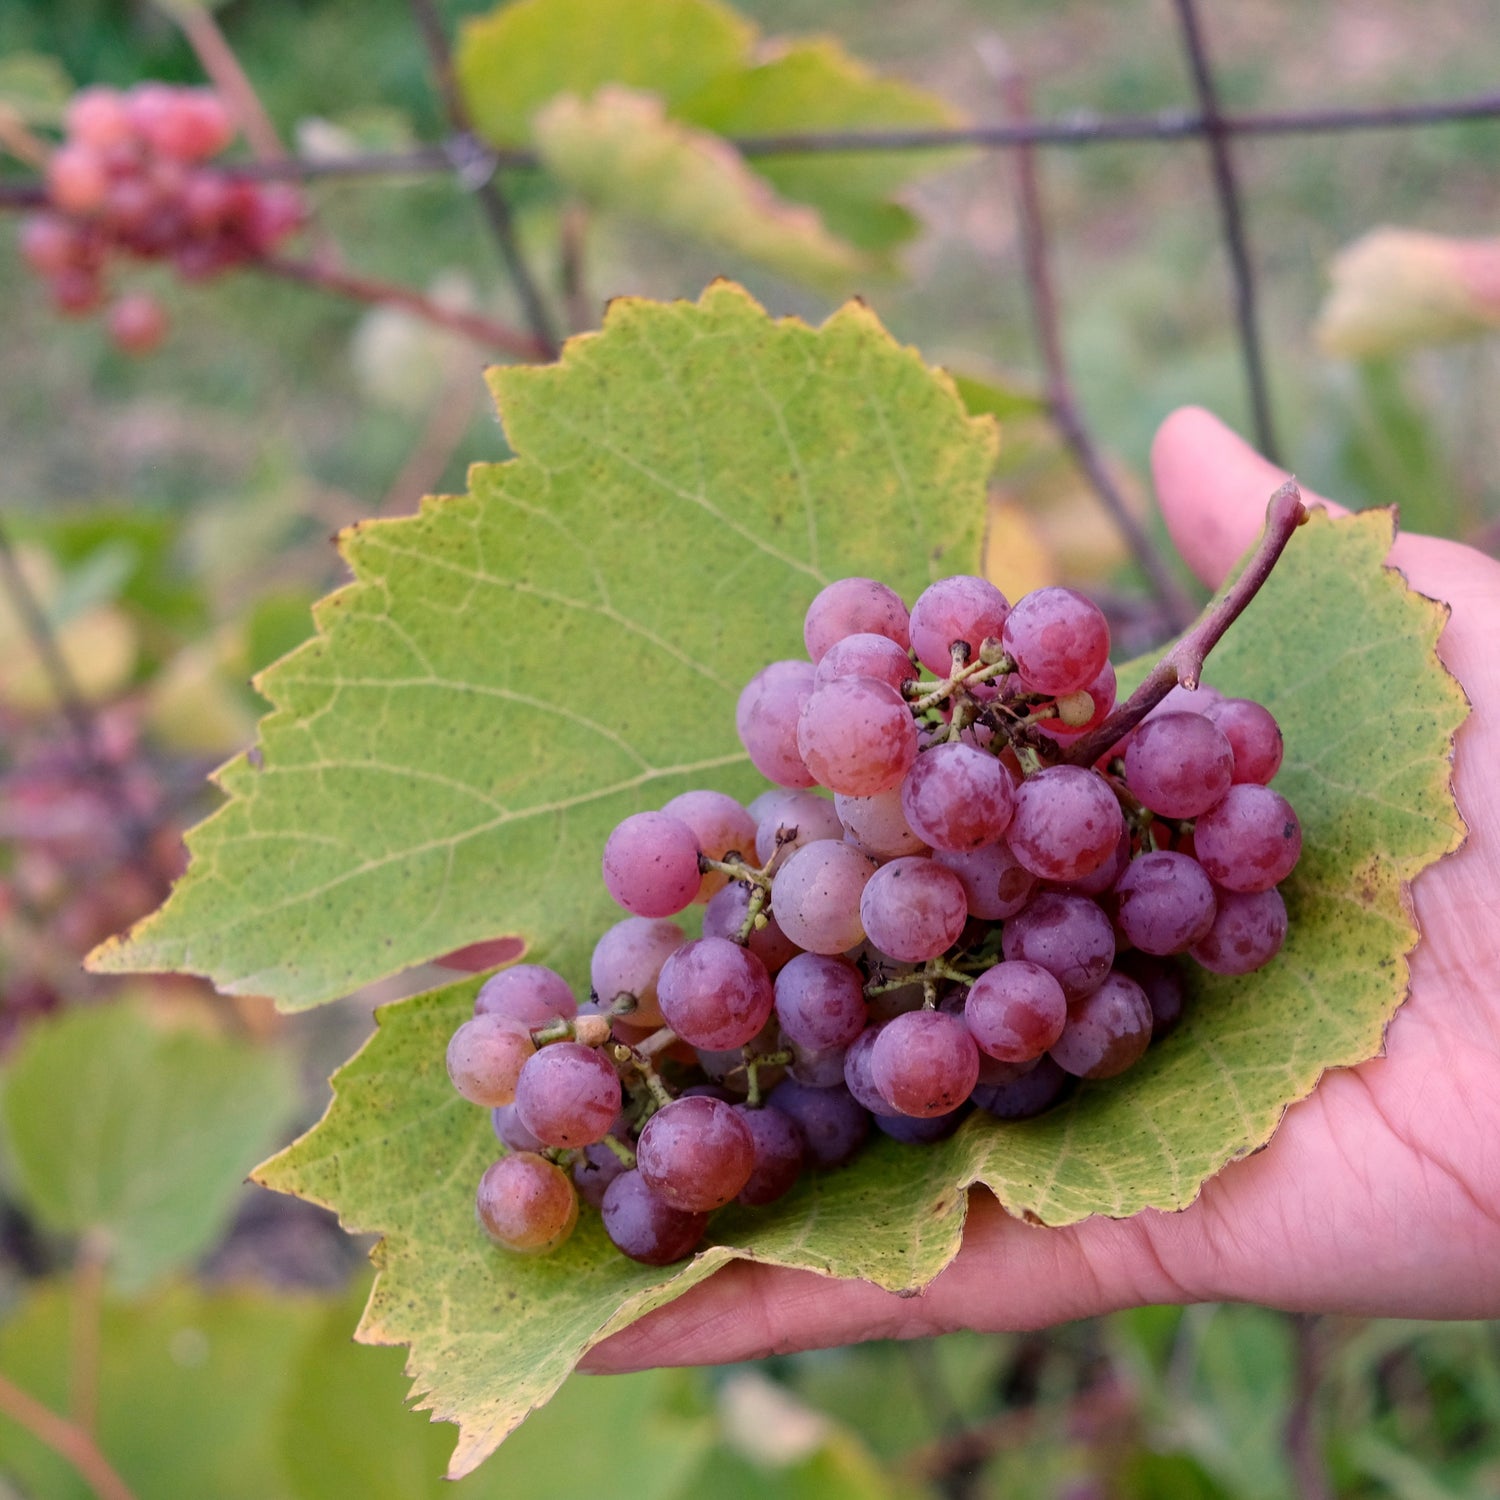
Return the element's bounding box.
[449,576,1301,1265]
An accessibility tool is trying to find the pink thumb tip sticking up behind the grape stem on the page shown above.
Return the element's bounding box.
[1151,407,1346,588]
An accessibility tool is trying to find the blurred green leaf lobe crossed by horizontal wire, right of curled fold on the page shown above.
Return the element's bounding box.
[672,38,959,252]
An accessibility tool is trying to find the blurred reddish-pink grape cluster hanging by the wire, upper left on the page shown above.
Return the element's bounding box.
[21,83,306,354]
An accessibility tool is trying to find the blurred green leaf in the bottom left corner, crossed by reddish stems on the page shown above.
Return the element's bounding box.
[0,1283,313,1500]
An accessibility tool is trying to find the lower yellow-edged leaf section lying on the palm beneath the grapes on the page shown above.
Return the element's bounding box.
[258,512,1466,1473]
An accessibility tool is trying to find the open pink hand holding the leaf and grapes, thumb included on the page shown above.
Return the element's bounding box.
[582,408,1500,1373]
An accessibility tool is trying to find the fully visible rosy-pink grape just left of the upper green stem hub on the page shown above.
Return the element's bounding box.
[797,677,917,797]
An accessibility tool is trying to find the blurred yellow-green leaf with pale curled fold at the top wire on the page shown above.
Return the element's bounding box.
[456,0,956,290]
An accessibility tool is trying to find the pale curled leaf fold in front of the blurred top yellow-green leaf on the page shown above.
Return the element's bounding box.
[536,86,878,291]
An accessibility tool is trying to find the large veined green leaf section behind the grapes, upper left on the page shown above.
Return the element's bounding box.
[93,284,995,1010]
